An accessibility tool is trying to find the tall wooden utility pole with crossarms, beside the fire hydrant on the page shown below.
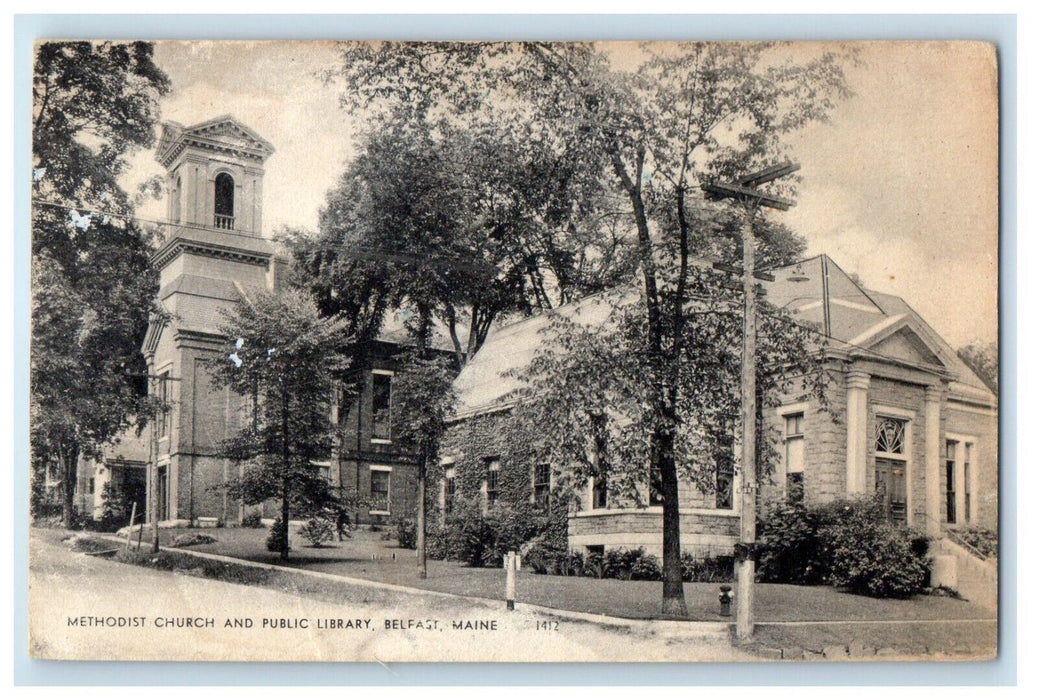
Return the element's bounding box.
[702,163,800,640]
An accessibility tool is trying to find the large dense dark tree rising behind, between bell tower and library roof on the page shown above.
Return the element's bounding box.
[295,69,634,366]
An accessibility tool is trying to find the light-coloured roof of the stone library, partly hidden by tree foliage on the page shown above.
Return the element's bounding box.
[455,254,994,418]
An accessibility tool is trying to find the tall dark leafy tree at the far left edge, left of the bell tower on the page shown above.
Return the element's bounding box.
[30,42,169,526]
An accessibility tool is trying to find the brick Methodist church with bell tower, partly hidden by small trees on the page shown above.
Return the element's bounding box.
[79,116,444,524]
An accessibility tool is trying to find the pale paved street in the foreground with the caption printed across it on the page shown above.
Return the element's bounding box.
[29,532,749,663]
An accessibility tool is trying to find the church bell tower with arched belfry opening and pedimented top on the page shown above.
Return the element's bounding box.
[142,116,285,524]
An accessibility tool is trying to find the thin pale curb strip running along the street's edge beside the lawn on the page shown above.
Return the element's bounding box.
[90,533,731,639]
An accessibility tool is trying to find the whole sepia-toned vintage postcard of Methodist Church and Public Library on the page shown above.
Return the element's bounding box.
[25,41,999,663]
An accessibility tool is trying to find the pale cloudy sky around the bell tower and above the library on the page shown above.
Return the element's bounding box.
[125,42,999,347]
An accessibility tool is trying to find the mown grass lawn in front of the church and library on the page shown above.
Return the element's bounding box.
[150,521,991,623]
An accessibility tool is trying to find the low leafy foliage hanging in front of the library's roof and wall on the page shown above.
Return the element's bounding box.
[510,275,827,515]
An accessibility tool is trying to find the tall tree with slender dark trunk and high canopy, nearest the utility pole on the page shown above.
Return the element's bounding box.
[331,43,849,617]
